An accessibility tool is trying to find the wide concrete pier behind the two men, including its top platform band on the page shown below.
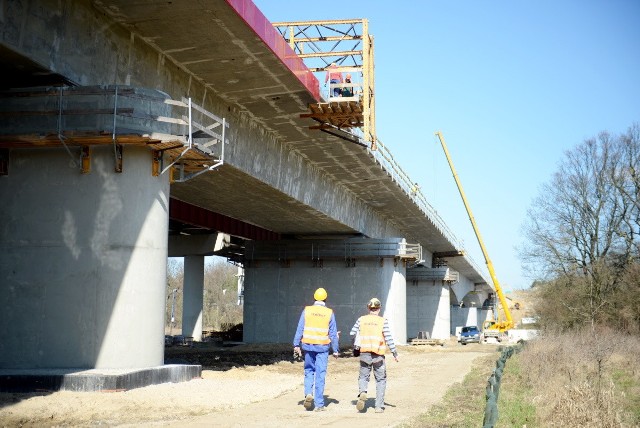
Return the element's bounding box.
[244,238,416,345]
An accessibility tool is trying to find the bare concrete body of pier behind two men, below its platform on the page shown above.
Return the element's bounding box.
[244,249,407,344]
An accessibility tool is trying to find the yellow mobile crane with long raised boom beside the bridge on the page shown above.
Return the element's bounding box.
[436,131,513,341]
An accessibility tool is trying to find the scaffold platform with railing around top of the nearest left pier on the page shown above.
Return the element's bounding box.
[0,85,229,182]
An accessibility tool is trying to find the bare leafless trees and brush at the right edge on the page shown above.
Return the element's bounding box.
[521,123,640,334]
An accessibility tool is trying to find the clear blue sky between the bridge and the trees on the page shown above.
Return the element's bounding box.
[254,0,640,291]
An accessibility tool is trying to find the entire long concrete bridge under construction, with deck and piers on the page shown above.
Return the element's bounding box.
[0,0,492,389]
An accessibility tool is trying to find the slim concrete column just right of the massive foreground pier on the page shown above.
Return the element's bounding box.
[182,256,204,342]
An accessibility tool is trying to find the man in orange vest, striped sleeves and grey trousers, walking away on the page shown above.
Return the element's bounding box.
[349,297,398,413]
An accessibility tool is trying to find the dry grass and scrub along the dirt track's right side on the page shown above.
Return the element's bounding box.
[401,329,640,428]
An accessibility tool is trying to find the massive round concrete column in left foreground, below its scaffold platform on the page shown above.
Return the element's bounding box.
[0,145,169,369]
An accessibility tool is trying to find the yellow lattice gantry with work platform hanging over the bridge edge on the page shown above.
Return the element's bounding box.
[273,19,377,150]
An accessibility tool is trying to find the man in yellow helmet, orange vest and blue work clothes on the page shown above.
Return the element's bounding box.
[293,288,340,412]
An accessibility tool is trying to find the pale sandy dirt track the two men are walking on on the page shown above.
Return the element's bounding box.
[0,341,497,428]
